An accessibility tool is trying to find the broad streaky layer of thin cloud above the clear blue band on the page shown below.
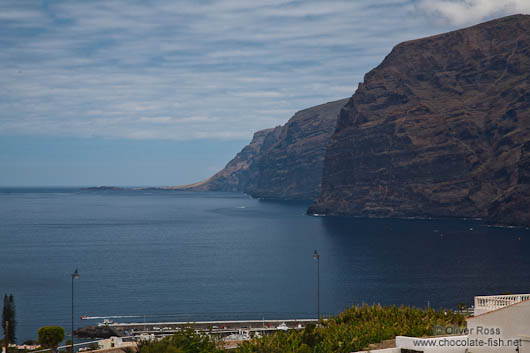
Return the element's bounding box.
[0,0,462,139]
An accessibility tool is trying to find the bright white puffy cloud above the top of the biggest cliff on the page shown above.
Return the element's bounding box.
[419,0,530,26]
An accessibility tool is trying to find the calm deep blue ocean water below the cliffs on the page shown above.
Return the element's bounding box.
[0,188,530,342]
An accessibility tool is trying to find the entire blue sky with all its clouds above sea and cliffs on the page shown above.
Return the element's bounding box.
[0,0,530,186]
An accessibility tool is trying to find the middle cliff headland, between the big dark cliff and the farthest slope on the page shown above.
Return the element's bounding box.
[246,99,348,200]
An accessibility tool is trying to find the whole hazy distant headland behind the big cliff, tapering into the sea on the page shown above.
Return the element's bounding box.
[177,99,348,200]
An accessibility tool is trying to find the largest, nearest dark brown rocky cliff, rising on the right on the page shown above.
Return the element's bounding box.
[308,15,530,225]
